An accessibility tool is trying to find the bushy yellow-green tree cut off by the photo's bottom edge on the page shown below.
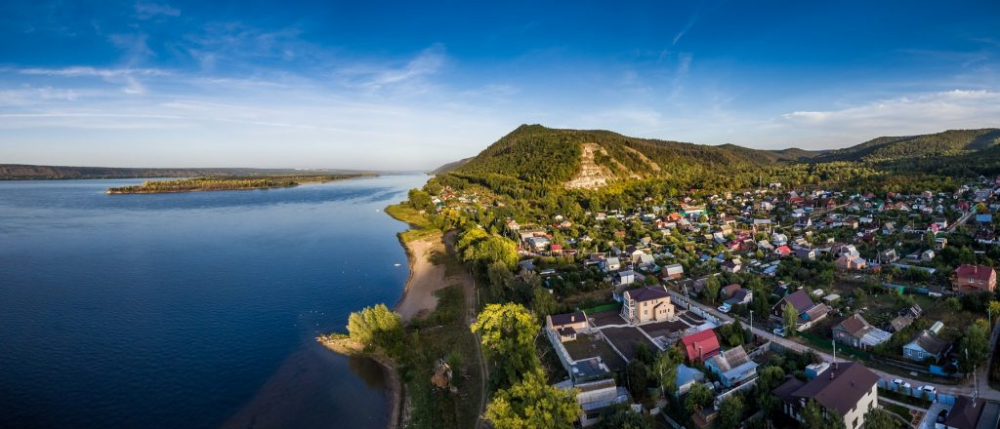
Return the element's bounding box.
[485,369,583,429]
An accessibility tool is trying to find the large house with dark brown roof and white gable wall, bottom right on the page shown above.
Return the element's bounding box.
[772,362,879,429]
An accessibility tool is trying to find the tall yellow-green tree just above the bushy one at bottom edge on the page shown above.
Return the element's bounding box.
[472,304,539,387]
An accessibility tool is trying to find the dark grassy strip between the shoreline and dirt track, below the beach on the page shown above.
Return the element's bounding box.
[404,285,483,428]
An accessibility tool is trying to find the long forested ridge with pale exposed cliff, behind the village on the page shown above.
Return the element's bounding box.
[434,125,1000,203]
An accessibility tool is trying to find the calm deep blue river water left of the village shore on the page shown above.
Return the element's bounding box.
[0,176,426,428]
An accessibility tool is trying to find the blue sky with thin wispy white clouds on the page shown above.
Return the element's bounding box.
[0,0,1000,169]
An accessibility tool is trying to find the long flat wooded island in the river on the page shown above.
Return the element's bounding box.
[106,174,375,194]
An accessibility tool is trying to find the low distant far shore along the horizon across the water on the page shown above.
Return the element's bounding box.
[0,164,372,180]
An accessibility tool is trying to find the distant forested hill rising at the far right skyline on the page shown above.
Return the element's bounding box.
[815,128,1000,162]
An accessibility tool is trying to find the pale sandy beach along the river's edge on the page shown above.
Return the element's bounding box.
[393,234,461,322]
